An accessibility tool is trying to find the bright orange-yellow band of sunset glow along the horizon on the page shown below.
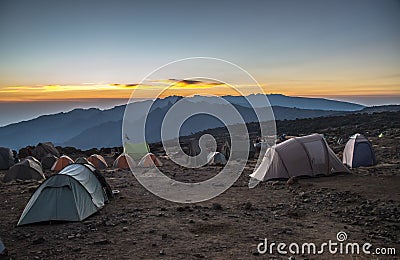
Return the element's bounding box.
[0,80,400,102]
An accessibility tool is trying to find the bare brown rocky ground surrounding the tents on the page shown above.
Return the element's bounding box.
[0,113,400,259]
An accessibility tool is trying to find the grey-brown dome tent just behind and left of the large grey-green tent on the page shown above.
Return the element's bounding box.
[3,159,45,182]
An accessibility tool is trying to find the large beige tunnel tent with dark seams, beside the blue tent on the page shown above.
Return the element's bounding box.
[250,134,349,181]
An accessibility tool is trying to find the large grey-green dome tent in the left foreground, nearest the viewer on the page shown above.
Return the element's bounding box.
[18,164,108,226]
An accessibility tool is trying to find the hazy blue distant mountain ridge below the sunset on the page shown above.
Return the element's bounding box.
[0,94,374,149]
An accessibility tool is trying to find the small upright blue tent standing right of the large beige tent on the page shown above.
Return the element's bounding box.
[343,134,376,168]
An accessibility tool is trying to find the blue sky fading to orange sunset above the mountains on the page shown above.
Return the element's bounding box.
[0,0,400,125]
